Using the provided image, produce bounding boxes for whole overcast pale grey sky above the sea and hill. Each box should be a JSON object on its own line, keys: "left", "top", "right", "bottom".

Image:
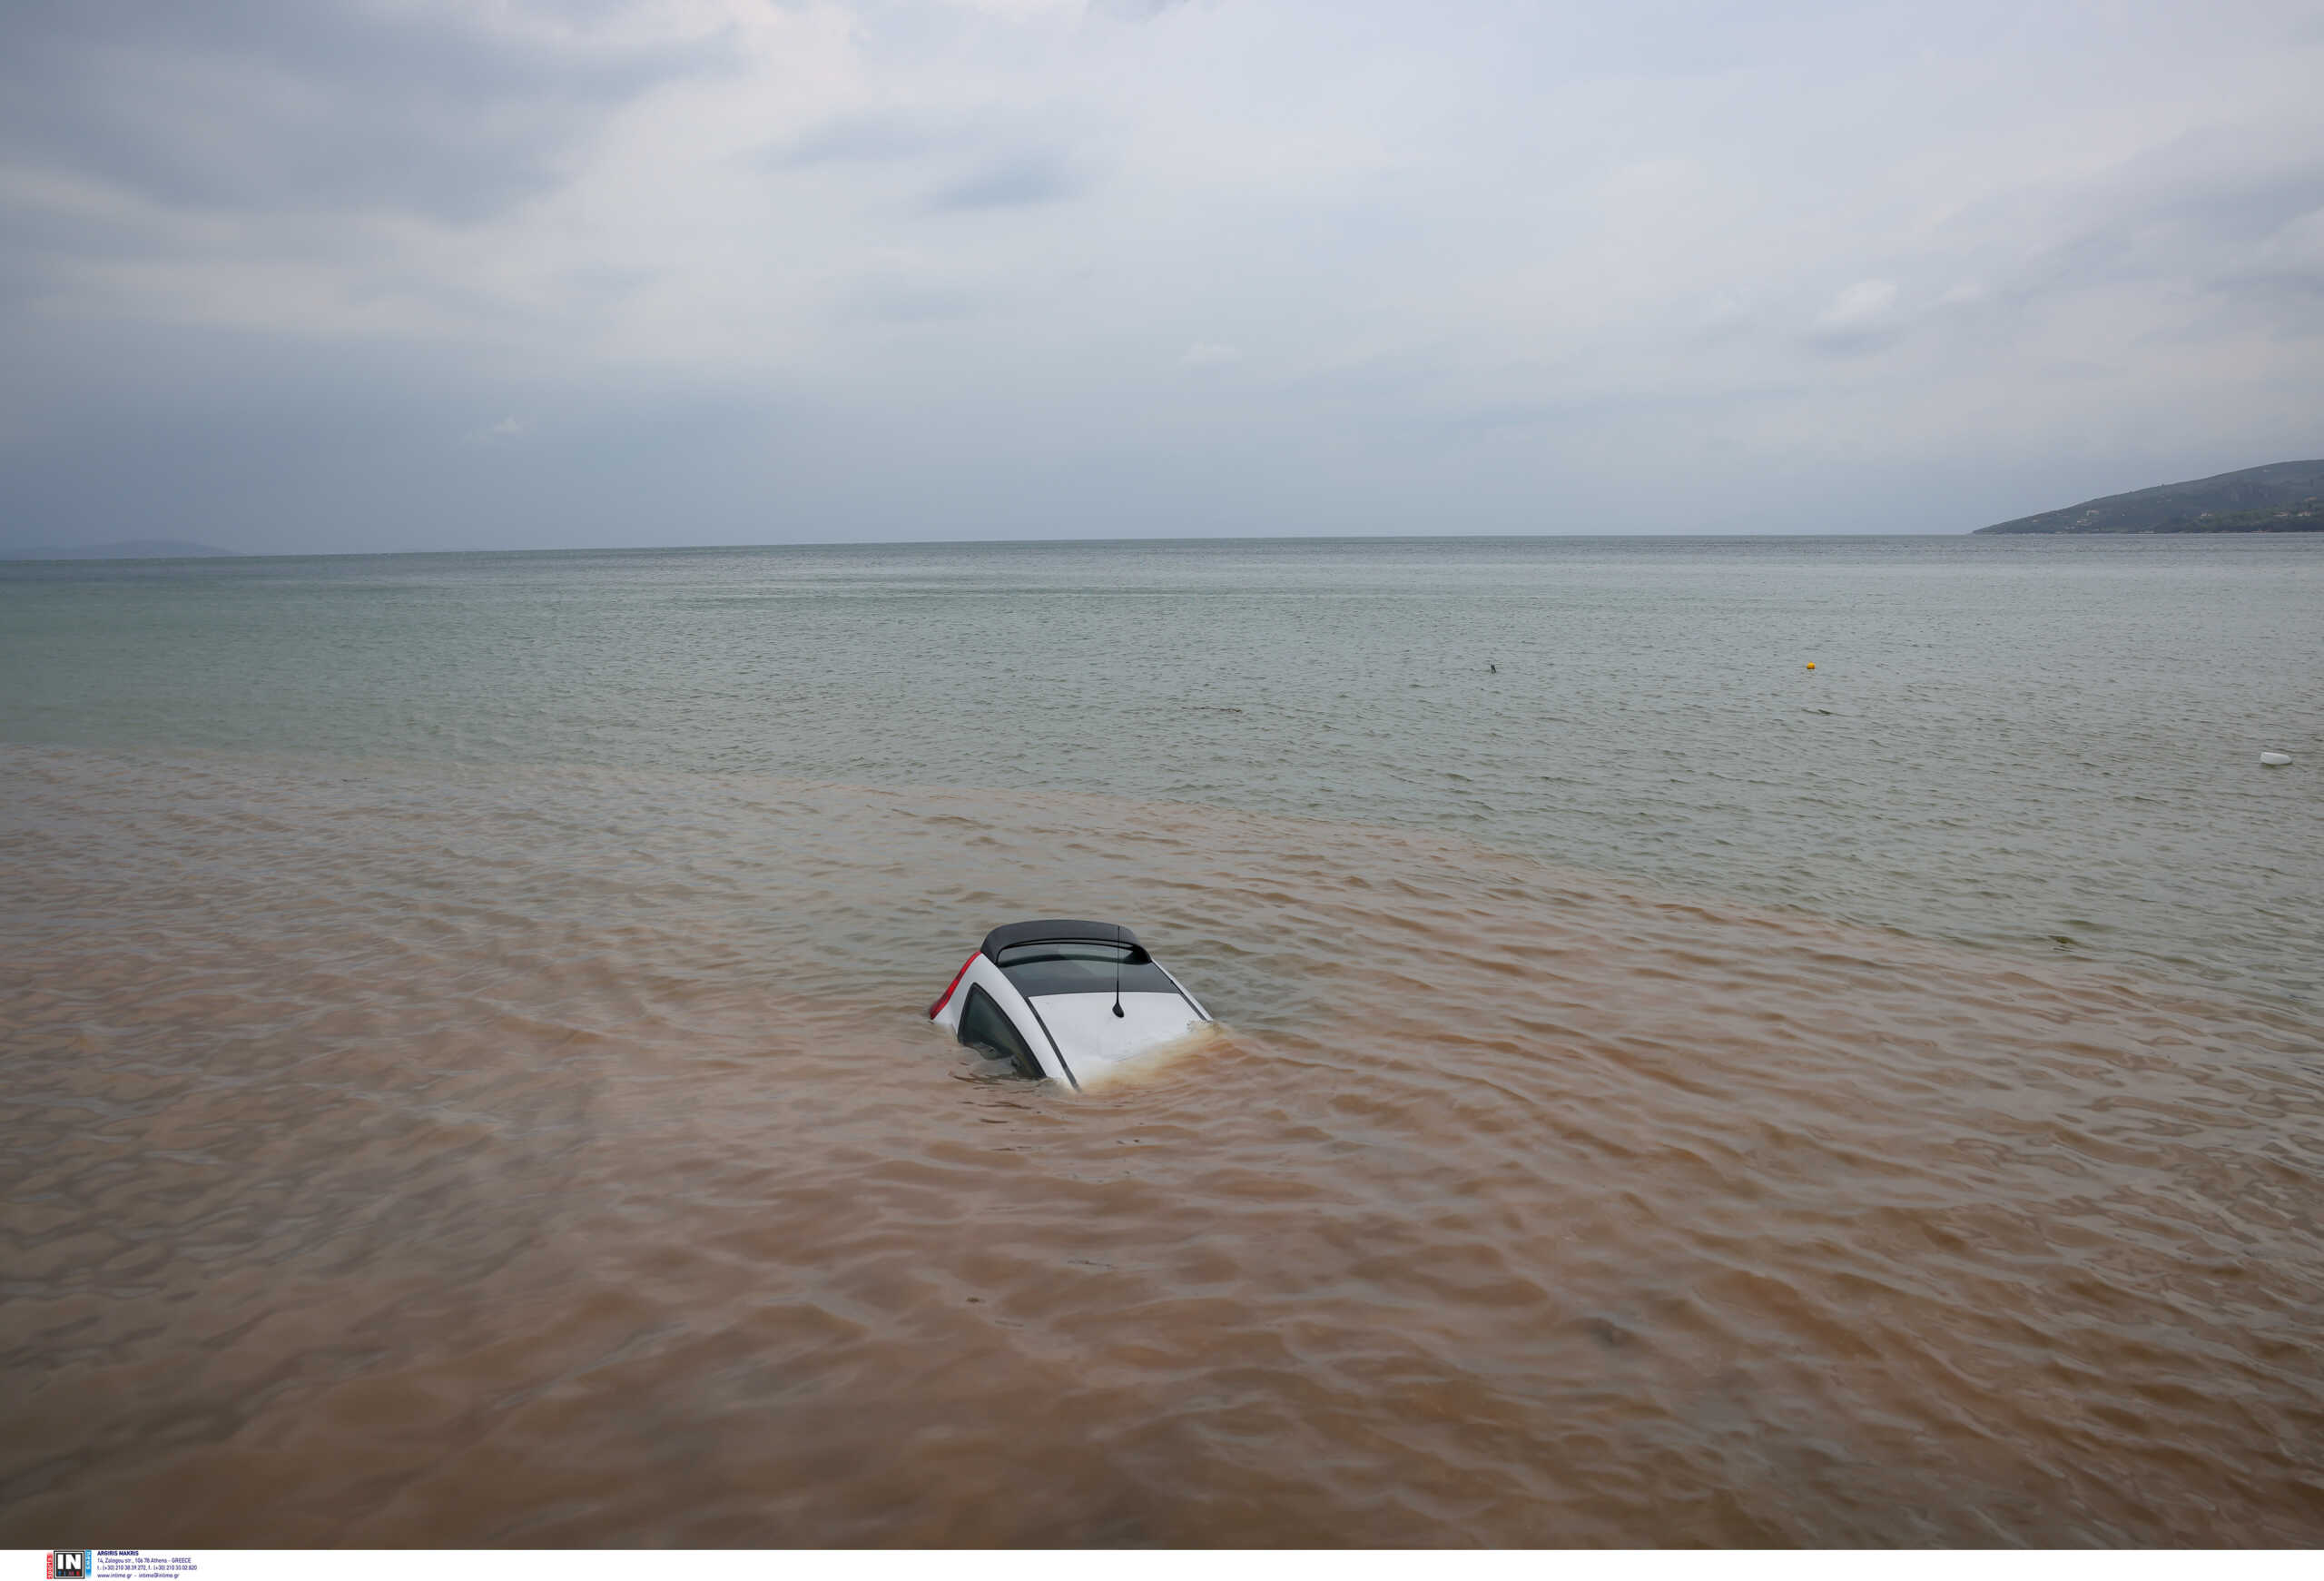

{"left": 0, "top": 0, "right": 2324, "bottom": 553}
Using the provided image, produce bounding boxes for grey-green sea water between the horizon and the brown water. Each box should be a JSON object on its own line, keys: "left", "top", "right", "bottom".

{"left": 0, "top": 537, "right": 2324, "bottom": 1007}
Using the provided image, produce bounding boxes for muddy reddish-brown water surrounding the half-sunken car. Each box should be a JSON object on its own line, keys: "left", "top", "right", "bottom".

{"left": 0, "top": 746, "right": 2324, "bottom": 1546}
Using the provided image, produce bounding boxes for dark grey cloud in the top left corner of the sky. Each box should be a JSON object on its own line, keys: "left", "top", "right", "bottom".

{"left": 0, "top": 0, "right": 723, "bottom": 221}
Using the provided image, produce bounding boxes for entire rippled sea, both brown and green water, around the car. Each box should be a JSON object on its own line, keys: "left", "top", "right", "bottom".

{"left": 0, "top": 537, "right": 2324, "bottom": 1546}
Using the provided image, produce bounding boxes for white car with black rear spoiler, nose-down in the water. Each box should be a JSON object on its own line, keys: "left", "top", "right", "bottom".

{"left": 927, "top": 918, "right": 1211, "bottom": 1091}
